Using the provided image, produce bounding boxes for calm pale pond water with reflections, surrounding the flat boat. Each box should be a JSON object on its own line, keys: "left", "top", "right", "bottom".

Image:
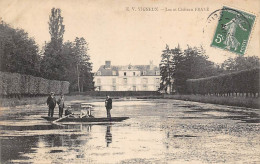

{"left": 0, "top": 100, "right": 260, "bottom": 163}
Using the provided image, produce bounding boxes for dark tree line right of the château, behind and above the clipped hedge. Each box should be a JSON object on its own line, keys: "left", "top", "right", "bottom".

{"left": 159, "top": 45, "right": 260, "bottom": 94}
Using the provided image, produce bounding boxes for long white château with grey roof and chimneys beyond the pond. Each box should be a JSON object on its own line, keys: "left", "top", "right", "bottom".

{"left": 94, "top": 61, "right": 161, "bottom": 91}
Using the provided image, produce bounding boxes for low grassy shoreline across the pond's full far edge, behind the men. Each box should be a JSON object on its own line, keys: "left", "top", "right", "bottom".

{"left": 0, "top": 95, "right": 260, "bottom": 109}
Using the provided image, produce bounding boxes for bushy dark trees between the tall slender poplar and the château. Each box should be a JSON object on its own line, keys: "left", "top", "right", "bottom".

{"left": 61, "top": 37, "right": 94, "bottom": 92}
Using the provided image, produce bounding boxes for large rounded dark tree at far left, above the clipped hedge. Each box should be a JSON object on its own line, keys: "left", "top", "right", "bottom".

{"left": 0, "top": 21, "right": 40, "bottom": 76}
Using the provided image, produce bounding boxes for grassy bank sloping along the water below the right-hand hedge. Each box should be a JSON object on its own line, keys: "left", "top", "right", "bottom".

{"left": 164, "top": 95, "right": 260, "bottom": 109}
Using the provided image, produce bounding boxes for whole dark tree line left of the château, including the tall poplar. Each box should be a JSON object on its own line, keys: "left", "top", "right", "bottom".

{"left": 0, "top": 8, "right": 94, "bottom": 92}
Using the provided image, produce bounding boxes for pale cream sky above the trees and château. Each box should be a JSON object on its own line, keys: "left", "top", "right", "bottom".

{"left": 0, "top": 0, "right": 260, "bottom": 72}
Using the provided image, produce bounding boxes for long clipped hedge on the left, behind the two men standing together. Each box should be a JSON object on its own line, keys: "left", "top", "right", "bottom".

{"left": 0, "top": 72, "right": 69, "bottom": 96}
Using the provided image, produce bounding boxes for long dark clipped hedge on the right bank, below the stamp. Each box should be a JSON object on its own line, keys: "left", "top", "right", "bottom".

{"left": 186, "top": 69, "right": 260, "bottom": 96}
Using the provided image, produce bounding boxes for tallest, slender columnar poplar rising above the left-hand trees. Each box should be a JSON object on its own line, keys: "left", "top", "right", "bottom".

{"left": 41, "top": 8, "right": 65, "bottom": 80}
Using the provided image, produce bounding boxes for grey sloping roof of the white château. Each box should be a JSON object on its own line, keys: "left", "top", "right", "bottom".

{"left": 95, "top": 65, "right": 160, "bottom": 76}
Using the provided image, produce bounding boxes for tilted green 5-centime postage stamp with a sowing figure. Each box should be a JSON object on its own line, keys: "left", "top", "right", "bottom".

{"left": 211, "top": 6, "right": 255, "bottom": 55}
